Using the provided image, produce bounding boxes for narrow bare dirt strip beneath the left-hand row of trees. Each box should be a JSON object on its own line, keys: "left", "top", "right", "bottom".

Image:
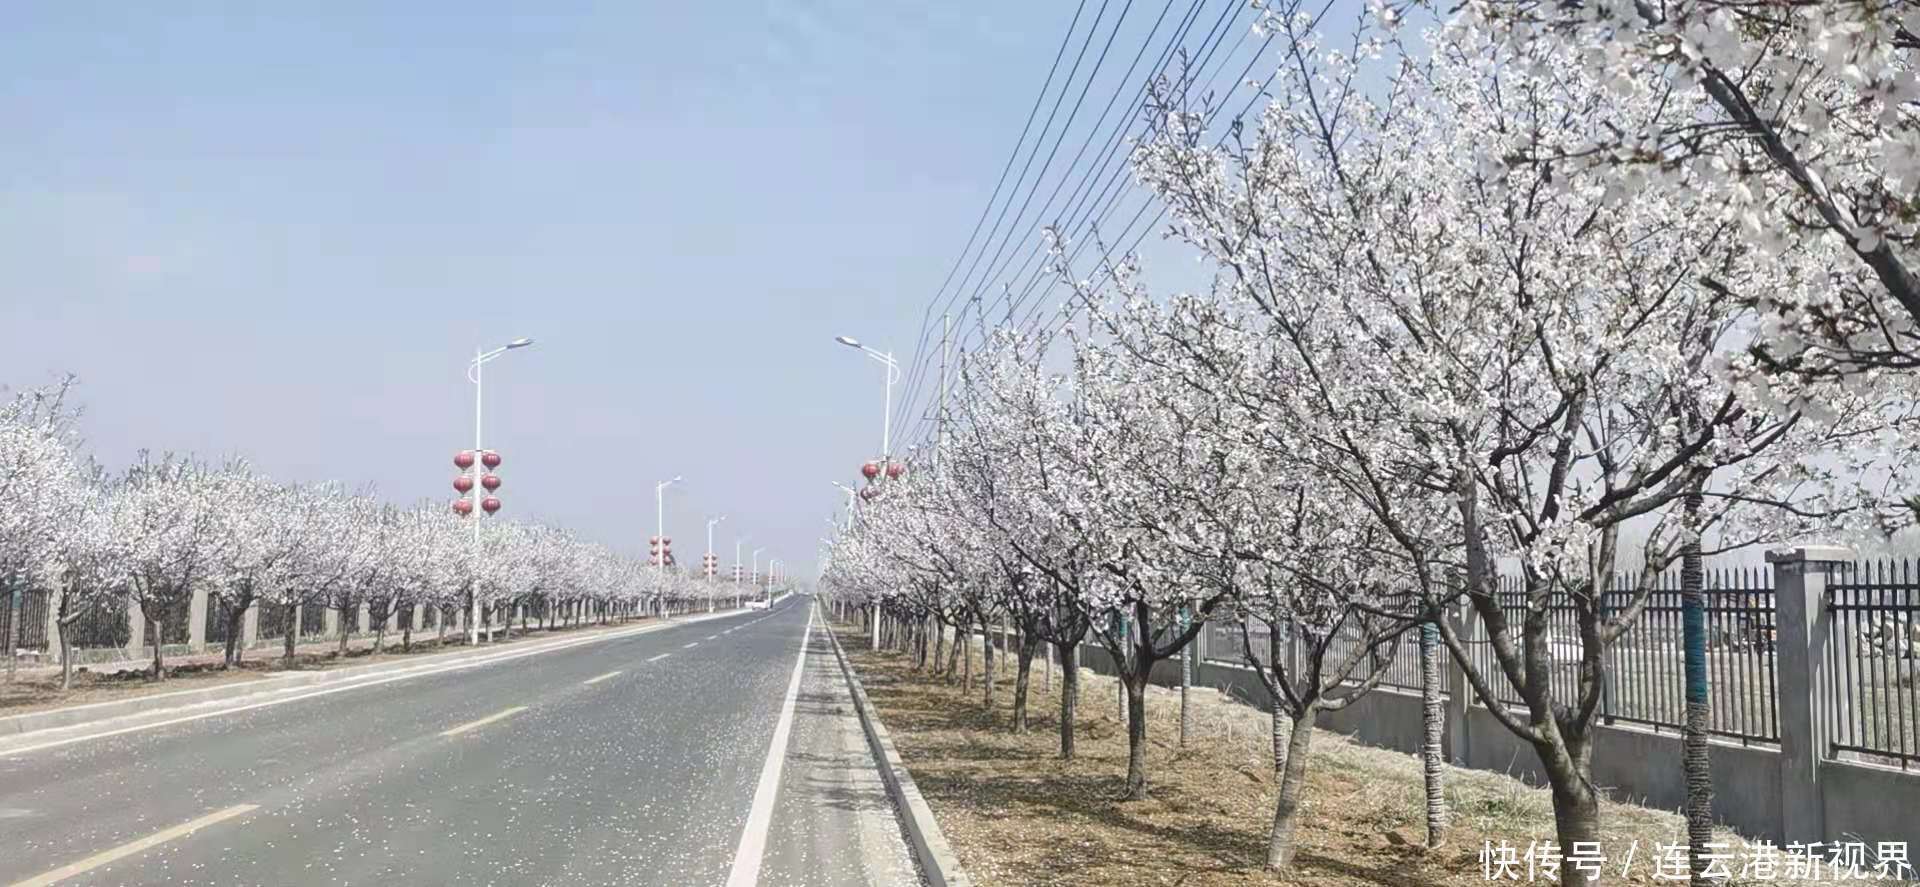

{"left": 0, "top": 618, "right": 651, "bottom": 716}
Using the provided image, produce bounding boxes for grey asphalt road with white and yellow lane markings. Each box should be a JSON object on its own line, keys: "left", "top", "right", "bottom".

{"left": 0, "top": 597, "right": 920, "bottom": 887}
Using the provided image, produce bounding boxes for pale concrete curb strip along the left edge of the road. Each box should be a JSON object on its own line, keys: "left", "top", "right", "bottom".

{"left": 0, "top": 609, "right": 755, "bottom": 739}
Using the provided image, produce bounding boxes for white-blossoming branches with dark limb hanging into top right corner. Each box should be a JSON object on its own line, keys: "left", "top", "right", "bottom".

{"left": 1455, "top": 0, "right": 1920, "bottom": 372}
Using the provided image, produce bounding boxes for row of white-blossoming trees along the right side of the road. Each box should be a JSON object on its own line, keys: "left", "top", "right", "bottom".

{"left": 824, "top": 0, "right": 1920, "bottom": 879}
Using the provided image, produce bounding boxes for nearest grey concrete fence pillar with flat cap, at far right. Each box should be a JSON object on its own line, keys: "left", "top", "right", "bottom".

{"left": 1766, "top": 545, "right": 1853, "bottom": 843}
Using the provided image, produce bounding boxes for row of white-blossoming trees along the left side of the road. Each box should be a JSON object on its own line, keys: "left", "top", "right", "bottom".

{"left": 0, "top": 380, "right": 735, "bottom": 683}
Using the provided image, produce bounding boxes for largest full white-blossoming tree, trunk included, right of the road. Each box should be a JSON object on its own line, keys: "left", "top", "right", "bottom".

{"left": 1137, "top": 12, "right": 1910, "bottom": 871}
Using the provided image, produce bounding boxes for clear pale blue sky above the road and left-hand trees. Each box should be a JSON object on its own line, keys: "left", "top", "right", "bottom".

{"left": 0, "top": 0, "right": 1290, "bottom": 568}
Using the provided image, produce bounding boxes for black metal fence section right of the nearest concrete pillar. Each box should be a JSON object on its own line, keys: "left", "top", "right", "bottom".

{"left": 1816, "top": 561, "right": 1920, "bottom": 770}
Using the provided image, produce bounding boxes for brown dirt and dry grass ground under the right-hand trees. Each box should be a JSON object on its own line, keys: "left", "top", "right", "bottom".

{"left": 839, "top": 626, "right": 1891, "bottom": 887}
